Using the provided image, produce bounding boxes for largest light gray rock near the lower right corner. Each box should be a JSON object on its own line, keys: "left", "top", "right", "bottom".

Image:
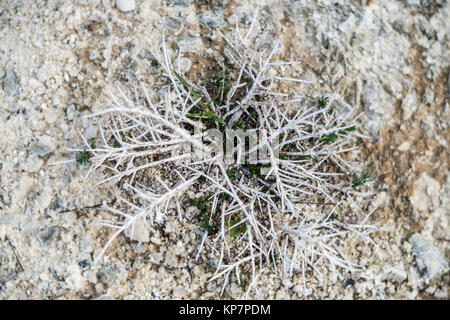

{"left": 409, "top": 233, "right": 447, "bottom": 279}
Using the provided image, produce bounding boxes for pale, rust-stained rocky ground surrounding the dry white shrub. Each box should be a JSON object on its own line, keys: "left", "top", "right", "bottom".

{"left": 0, "top": 0, "right": 450, "bottom": 299}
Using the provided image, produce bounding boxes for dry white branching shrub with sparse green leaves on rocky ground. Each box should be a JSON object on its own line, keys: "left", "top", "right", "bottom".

{"left": 73, "top": 10, "right": 376, "bottom": 297}
